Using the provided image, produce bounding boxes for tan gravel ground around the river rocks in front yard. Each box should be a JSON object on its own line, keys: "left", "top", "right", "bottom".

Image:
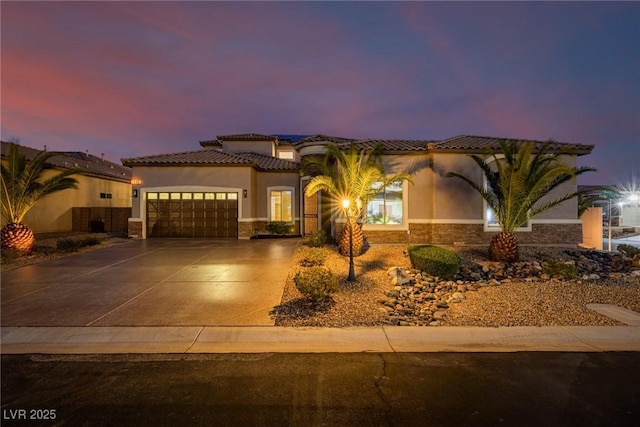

{"left": 272, "top": 245, "right": 640, "bottom": 327}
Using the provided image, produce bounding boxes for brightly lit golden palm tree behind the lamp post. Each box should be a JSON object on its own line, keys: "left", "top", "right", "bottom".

{"left": 302, "top": 144, "right": 411, "bottom": 256}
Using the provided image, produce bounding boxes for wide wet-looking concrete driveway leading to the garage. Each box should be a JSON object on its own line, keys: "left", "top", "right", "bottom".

{"left": 1, "top": 239, "right": 299, "bottom": 326}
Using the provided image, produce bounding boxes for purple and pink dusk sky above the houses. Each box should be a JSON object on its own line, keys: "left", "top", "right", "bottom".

{"left": 0, "top": 1, "right": 640, "bottom": 184}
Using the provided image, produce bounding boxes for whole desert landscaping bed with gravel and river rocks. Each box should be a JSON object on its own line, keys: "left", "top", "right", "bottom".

{"left": 272, "top": 244, "right": 640, "bottom": 327}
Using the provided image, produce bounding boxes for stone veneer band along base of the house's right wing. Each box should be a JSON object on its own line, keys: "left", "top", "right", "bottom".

{"left": 336, "top": 223, "right": 582, "bottom": 245}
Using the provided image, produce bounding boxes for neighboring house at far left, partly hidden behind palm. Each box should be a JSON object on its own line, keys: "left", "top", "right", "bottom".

{"left": 2, "top": 141, "right": 131, "bottom": 233}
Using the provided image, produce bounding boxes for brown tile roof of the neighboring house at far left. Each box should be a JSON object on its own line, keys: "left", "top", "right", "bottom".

{"left": 2, "top": 141, "right": 131, "bottom": 182}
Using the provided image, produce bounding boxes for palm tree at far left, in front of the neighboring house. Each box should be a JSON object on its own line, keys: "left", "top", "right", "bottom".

{"left": 0, "top": 143, "right": 82, "bottom": 255}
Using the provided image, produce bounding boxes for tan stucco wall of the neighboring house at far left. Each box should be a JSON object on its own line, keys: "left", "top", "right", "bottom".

{"left": 23, "top": 171, "right": 131, "bottom": 233}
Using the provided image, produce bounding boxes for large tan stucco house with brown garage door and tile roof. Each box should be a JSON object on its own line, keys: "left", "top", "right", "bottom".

{"left": 122, "top": 134, "right": 593, "bottom": 245}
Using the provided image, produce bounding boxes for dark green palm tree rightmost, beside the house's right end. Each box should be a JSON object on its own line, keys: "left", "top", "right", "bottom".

{"left": 446, "top": 141, "right": 595, "bottom": 262}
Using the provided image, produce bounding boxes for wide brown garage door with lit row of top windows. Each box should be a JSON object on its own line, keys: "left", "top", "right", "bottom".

{"left": 147, "top": 192, "right": 238, "bottom": 238}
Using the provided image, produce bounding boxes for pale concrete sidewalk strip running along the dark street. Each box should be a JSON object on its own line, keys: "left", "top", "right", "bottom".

{"left": 1, "top": 326, "right": 640, "bottom": 354}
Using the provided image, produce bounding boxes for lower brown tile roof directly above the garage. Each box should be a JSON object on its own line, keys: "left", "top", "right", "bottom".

{"left": 122, "top": 149, "right": 300, "bottom": 171}
